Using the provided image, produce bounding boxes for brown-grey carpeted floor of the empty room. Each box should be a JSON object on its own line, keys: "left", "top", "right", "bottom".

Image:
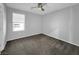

{"left": 2, "top": 34, "right": 79, "bottom": 55}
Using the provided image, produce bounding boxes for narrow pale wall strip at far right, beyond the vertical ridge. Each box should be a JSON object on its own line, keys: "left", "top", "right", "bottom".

{"left": 72, "top": 5, "right": 79, "bottom": 46}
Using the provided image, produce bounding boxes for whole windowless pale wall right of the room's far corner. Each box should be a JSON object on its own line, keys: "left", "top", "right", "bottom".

{"left": 43, "top": 5, "right": 79, "bottom": 46}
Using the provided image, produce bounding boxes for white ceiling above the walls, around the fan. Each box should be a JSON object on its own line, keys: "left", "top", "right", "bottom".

{"left": 6, "top": 3, "right": 77, "bottom": 15}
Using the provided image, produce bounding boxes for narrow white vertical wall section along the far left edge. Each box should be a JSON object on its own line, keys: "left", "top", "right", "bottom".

{"left": 0, "top": 3, "right": 6, "bottom": 52}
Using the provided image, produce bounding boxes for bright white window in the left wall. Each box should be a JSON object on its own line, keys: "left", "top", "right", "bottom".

{"left": 12, "top": 13, "right": 25, "bottom": 31}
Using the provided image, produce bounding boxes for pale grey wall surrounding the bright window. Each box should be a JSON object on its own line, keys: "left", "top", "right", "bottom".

{"left": 6, "top": 7, "right": 41, "bottom": 41}
